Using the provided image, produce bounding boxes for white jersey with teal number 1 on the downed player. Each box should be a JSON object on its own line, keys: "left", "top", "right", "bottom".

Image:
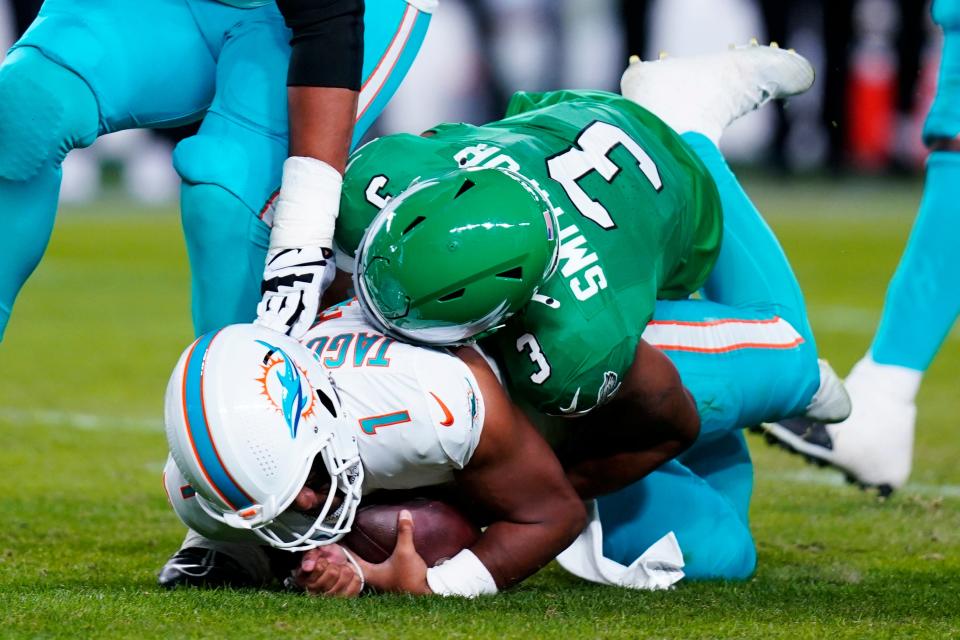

{"left": 302, "top": 300, "right": 484, "bottom": 493}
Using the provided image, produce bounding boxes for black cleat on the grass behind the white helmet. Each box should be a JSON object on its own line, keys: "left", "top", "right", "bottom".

{"left": 157, "top": 547, "right": 262, "bottom": 589}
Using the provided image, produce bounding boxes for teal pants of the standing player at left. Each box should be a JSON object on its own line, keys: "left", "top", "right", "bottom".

{"left": 0, "top": 0, "right": 429, "bottom": 335}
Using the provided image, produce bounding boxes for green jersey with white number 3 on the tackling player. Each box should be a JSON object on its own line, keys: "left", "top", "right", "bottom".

{"left": 336, "top": 91, "right": 722, "bottom": 414}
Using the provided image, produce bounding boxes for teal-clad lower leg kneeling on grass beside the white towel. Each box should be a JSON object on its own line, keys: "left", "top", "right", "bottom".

{"left": 597, "top": 450, "right": 757, "bottom": 580}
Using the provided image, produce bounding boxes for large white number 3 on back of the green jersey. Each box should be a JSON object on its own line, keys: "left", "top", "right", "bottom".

{"left": 547, "top": 121, "right": 663, "bottom": 229}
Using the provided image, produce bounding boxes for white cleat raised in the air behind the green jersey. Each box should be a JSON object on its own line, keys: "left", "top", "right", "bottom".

{"left": 620, "top": 39, "right": 814, "bottom": 142}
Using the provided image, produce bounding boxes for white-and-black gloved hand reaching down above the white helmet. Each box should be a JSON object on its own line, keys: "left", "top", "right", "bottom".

{"left": 255, "top": 247, "right": 337, "bottom": 339}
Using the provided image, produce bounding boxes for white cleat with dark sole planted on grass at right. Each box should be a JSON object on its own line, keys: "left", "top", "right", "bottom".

{"left": 764, "top": 357, "right": 920, "bottom": 496}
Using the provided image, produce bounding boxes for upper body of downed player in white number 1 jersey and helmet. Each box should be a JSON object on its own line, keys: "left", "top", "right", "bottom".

{"left": 161, "top": 302, "right": 585, "bottom": 596}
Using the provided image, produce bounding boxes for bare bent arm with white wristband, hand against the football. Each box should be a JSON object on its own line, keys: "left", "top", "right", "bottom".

{"left": 366, "top": 349, "right": 586, "bottom": 597}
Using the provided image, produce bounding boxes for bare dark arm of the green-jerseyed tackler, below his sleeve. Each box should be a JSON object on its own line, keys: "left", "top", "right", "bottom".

{"left": 562, "top": 340, "right": 700, "bottom": 499}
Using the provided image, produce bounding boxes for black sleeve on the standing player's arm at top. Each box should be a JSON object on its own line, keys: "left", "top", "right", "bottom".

{"left": 277, "top": 0, "right": 364, "bottom": 91}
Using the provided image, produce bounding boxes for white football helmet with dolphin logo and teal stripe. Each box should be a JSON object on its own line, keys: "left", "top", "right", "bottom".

{"left": 164, "top": 324, "right": 363, "bottom": 551}
